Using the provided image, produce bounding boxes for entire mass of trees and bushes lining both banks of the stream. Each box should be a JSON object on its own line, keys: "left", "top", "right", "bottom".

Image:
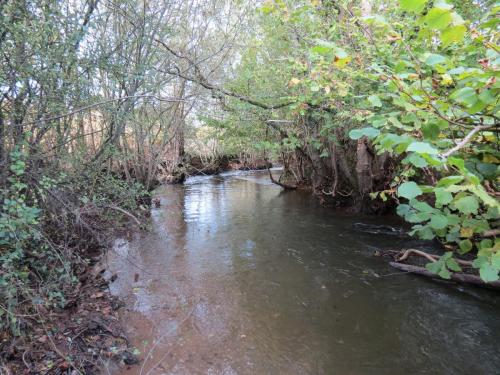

{"left": 0, "top": 0, "right": 500, "bottom": 356}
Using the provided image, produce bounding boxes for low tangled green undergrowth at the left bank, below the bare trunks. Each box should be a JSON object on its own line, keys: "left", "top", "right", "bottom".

{"left": 0, "top": 147, "right": 148, "bottom": 343}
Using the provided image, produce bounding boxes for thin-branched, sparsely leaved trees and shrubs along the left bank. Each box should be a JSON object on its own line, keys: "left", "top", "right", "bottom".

{"left": 0, "top": 0, "right": 250, "bottom": 345}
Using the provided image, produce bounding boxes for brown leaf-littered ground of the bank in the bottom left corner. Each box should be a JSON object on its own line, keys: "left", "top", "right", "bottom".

{"left": 0, "top": 244, "right": 138, "bottom": 375}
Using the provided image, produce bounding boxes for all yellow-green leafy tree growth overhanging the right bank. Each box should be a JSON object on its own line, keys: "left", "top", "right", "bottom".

{"left": 221, "top": 0, "right": 500, "bottom": 281}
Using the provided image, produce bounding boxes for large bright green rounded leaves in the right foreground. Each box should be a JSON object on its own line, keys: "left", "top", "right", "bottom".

{"left": 358, "top": 1, "right": 500, "bottom": 281}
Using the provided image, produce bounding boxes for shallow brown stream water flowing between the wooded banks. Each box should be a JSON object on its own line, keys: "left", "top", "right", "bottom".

{"left": 108, "top": 172, "right": 500, "bottom": 375}
